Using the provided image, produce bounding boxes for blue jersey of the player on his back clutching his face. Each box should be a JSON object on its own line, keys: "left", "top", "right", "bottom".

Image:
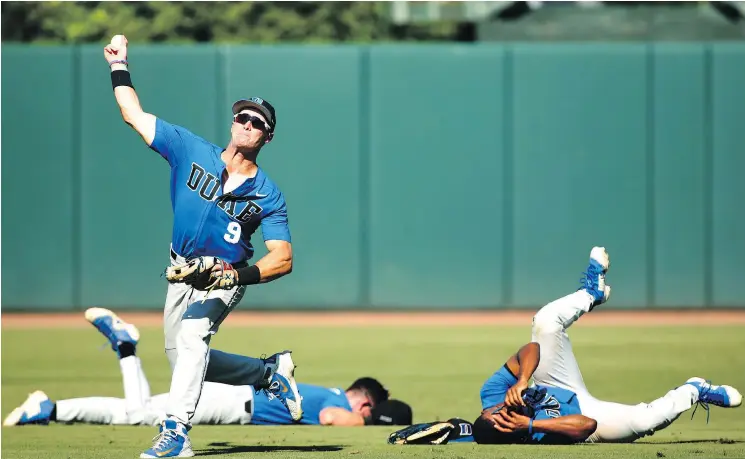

{"left": 481, "top": 365, "right": 582, "bottom": 443}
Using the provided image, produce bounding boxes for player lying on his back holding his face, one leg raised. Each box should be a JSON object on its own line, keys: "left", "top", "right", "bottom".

{"left": 389, "top": 247, "right": 742, "bottom": 444}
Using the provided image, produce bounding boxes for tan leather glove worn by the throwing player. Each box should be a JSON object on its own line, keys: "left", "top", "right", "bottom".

{"left": 165, "top": 256, "right": 237, "bottom": 290}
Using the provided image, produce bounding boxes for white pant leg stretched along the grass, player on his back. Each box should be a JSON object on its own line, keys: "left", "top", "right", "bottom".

{"left": 577, "top": 384, "right": 698, "bottom": 443}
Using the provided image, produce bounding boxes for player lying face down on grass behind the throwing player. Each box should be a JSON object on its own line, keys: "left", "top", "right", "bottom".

{"left": 4, "top": 308, "right": 412, "bottom": 432}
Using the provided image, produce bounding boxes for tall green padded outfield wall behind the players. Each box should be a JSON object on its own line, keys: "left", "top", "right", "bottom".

{"left": 2, "top": 43, "right": 745, "bottom": 310}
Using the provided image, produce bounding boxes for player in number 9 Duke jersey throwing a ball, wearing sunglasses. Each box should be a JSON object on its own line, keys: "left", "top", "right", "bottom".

{"left": 104, "top": 35, "right": 302, "bottom": 458}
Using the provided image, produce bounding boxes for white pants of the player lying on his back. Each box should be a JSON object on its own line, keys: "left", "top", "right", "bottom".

{"left": 532, "top": 290, "right": 698, "bottom": 443}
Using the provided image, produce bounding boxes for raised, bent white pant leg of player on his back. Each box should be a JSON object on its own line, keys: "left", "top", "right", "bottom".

{"left": 532, "top": 290, "right": 594, "bottom": 393}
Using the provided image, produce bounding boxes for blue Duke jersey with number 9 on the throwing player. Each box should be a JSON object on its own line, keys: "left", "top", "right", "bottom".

{"left": 150, "top": 118, "right": 291, "bottom": 263}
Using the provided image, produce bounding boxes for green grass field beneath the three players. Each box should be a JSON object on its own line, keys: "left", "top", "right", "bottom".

{"left": 2, "top": 317, "right": 745, "bottom": 459}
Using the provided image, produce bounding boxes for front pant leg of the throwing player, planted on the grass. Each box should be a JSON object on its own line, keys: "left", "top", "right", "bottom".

{"left": 164, "top": 250, "right": 245, "bottom": 425}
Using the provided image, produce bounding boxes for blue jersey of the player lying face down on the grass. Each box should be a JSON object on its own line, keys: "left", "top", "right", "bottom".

{"left": 251, "top": 383, "right": 352, "bottom": 425}
